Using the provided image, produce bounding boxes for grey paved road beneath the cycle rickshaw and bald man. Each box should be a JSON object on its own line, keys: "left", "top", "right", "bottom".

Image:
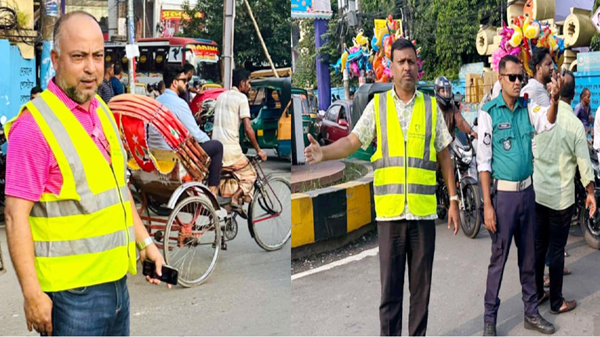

{"left": 0, "top": 151, "right": 291, "bottom": 335}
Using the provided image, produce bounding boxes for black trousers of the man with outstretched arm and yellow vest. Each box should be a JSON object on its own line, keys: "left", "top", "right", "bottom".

{"left": 377, "top": 220, "right": 435, "bottom": 336}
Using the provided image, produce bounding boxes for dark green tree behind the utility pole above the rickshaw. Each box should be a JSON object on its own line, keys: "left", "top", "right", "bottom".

{"left": 182, "top": 0, "right": 291, "bottom": 69}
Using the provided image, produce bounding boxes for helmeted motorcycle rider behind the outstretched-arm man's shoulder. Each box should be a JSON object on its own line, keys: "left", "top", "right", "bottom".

{"left": 433, "top": 76, "right": 477, "bottom": 139}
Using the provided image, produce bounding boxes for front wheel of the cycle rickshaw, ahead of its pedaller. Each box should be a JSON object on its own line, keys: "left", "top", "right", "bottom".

{"left": 248, "top": 177, "right": 292, "bottom": 251}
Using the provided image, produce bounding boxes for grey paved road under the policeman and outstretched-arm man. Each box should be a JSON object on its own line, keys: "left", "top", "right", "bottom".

{"left": 292, "top": 223, "right": 600, "bottom": 335}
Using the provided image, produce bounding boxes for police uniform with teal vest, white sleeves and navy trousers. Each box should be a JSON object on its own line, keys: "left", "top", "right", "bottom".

{"left": 477, "top": 95, "right": 554, "bottom": 325}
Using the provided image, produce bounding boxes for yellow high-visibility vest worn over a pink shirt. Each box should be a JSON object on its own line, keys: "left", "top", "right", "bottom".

{"left": 5, "top": 90, "right": 136, "bottom": 292}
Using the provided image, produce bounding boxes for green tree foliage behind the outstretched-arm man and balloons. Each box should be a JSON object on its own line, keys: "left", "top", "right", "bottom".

{"left": 296, "top": 0, "right": 502, "bottom": 86}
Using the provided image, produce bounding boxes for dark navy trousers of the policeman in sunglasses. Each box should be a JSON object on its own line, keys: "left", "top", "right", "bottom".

{"left": 484, "top": 186, "right": 539, "bottom": 324}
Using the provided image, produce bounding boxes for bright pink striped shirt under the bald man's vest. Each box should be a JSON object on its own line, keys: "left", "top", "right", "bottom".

{"left": 5, "top": 78, "right": 110, "bottom": 202}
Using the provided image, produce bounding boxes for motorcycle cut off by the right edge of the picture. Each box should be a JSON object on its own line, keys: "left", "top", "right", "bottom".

{"left": 573, "top": 141, "right": 600, "bottom": 249}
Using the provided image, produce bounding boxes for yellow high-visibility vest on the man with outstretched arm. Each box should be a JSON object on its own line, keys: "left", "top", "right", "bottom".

{"left": 371, "top": 89, "right": 437, "bottom": 218}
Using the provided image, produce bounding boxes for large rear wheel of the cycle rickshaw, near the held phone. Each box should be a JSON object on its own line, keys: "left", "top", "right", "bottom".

{"left": 163, "top": 196, "right": 221, "bottom": 287}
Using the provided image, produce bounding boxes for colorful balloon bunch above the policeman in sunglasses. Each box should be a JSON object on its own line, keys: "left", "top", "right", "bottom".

{"left": 492, "top": 16, "right": 565, "bottom": 76}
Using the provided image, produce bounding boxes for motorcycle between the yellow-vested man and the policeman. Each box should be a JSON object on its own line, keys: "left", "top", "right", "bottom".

{"left": 436, "top": 128, "right": 483, "bottom": 238}
